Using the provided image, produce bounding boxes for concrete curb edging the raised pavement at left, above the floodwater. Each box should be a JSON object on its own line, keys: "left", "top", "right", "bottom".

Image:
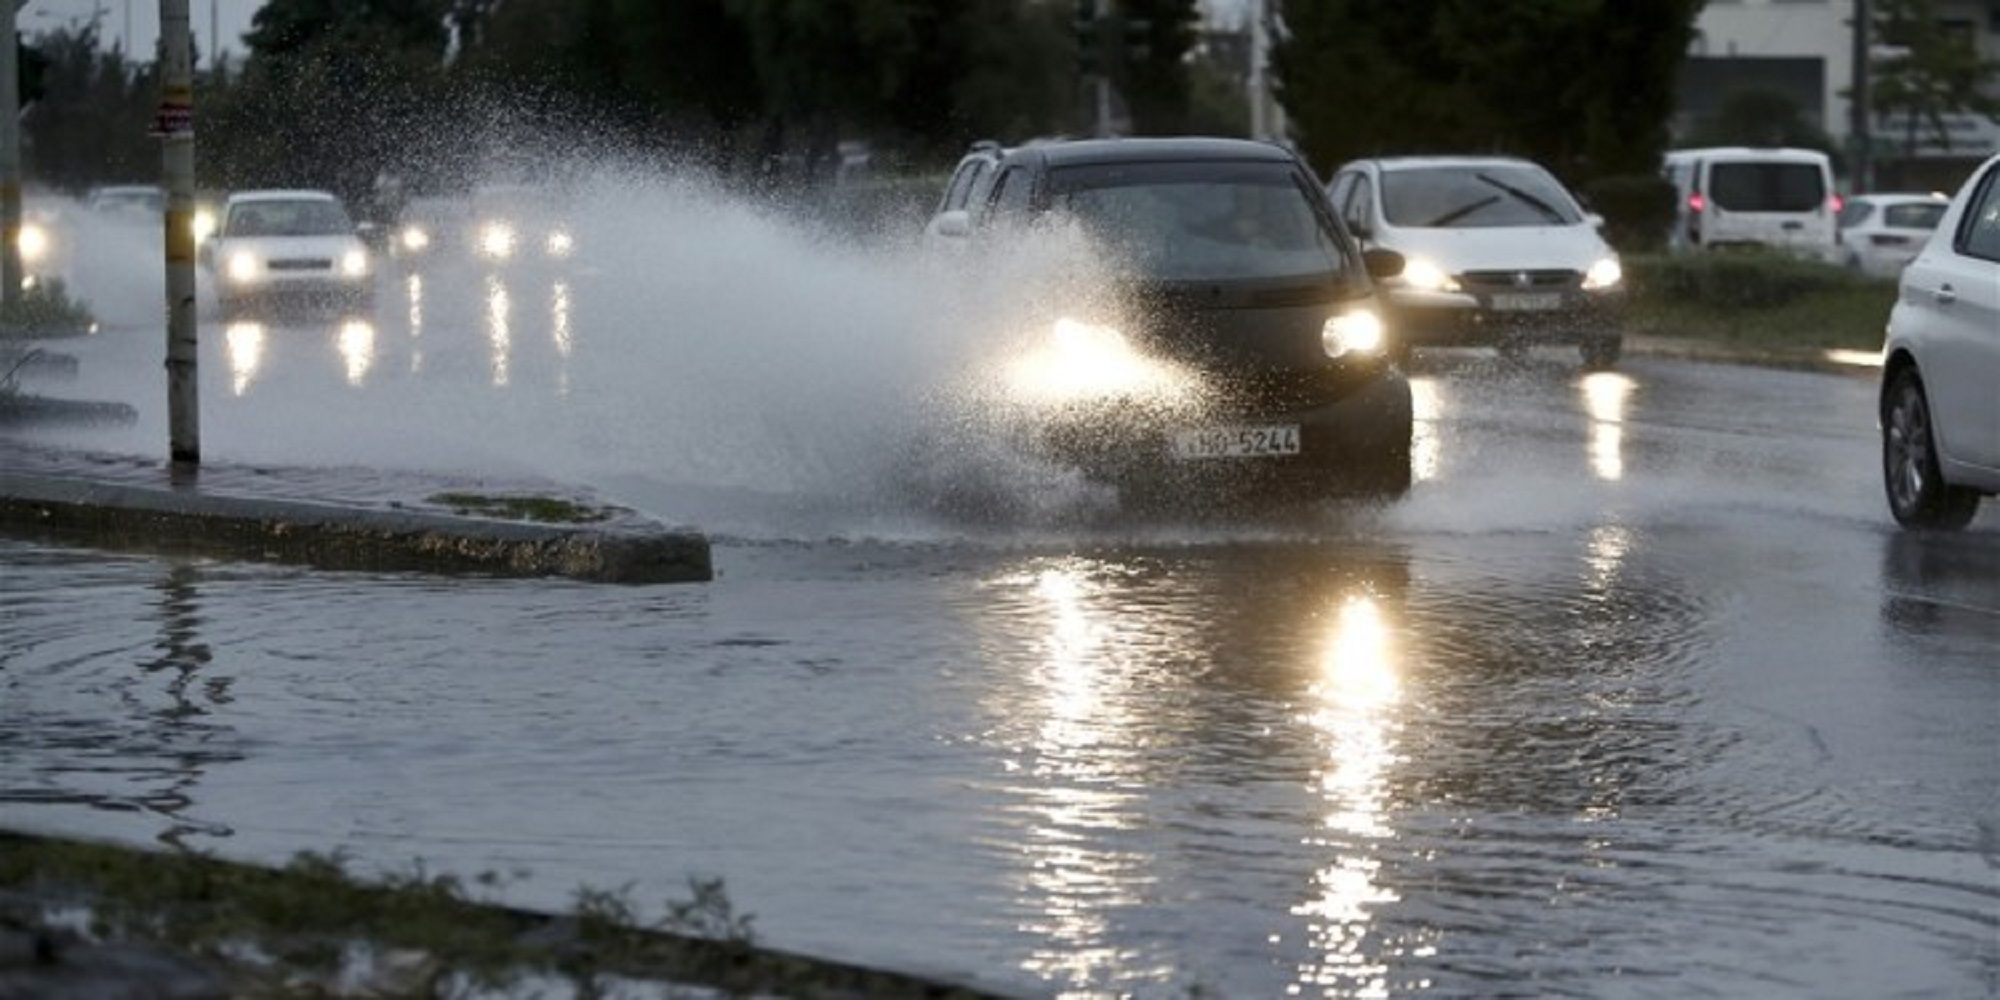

{"left": 0, "top": 470, "right": 714, "bottom": 584}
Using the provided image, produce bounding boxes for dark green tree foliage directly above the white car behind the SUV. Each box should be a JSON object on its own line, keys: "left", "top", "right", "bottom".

{"left": 1274, "top": 0, "right": 1702, "bottom": 184}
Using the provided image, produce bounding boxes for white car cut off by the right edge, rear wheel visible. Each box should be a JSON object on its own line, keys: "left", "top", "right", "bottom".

{"left": 1880, "top": 156, "right": 2000, "bottom": 528}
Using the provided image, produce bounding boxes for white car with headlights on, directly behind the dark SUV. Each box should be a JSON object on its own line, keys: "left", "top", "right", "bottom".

{"left": 1326, "top": 156, "right": 1624, "bottom": 368}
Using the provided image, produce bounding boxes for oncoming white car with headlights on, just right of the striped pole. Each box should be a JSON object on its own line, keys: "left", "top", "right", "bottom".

{"left": 202, "top": 190, "right": 374, "bottom": 316}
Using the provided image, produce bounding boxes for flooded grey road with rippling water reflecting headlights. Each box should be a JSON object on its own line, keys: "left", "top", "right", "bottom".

{"left": 0, "top": 207, "right": 2000, "bottom": 998}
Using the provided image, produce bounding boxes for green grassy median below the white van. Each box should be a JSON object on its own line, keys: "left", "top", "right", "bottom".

{"left": 1626, "top": 252, "right": 1896, "bottom": 350}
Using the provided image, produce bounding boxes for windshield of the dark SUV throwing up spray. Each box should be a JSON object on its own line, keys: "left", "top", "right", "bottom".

{"left": 1048, "top": 162, "right": 1350, "bottom": 284}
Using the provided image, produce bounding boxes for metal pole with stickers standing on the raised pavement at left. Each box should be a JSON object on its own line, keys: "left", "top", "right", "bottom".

{"left": 154, "top": 0, "right": 202, "bottom": 468}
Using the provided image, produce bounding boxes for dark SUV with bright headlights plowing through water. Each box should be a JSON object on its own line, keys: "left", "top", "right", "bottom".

{"left": 928, "top": 138, "right": 1412, "bottom": 496}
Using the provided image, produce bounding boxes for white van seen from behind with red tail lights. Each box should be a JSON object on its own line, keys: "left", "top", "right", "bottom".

{"left": 1662, "top": 146, "right": 1840, "bottom": 260}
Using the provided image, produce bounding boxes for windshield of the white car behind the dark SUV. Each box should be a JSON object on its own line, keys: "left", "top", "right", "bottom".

{"left": 1382, "top": 164, "right": 1584, "bottom": 228}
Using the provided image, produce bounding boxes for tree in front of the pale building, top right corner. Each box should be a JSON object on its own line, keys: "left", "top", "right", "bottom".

{"left": 1868, "top": 0, "right": 2000, "bottom": 154}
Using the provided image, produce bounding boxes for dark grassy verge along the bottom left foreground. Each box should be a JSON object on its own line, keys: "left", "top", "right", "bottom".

{"left": 0, "top": 832, "right": 986, "bottom": 1000}
